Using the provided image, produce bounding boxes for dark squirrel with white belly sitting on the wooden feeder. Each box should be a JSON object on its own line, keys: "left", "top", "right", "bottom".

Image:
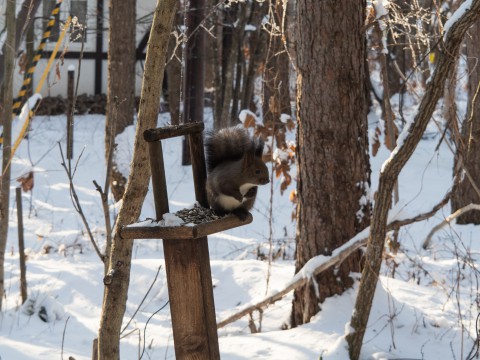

{"left": 205, "top": 126, "right": 270, "bottom": 221}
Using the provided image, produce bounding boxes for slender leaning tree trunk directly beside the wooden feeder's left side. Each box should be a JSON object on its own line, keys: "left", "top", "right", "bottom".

{"left": 98, "top": 0, "right": 178, "bottom": 360}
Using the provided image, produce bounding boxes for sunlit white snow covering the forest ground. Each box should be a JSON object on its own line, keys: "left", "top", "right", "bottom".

{"left": 0, "top": 87, "right": 480, "bottom": 360}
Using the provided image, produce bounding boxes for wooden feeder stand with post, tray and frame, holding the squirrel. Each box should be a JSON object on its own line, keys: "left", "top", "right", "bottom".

{"left": 120, "top": 123, "right": 252, "bottom": 360}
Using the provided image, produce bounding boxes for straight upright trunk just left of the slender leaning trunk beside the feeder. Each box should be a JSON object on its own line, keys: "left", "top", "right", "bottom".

{"left": 105, "top": 0, "right": 137, "bottom": 201}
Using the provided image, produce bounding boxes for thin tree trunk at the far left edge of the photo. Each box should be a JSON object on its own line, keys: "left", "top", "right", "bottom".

{"left": 0, "top": 0, "right": 15, "bottom": 310}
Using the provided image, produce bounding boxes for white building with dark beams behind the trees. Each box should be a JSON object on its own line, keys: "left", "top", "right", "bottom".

{"left": 6, "top": 0, "right": 156, "bottom": 98}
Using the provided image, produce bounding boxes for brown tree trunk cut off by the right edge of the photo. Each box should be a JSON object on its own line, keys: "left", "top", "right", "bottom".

{"left": 452, "top": 23, "right": 480, "bottom": 224}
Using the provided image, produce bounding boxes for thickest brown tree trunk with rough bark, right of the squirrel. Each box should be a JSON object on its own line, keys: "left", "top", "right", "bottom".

{"left": 291, "top": 0, "right": 370, "bottom": 326}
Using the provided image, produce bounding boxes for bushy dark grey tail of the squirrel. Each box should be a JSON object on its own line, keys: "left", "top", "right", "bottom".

{"left": 205, "top": 126, "right": 264, "bottom": 173}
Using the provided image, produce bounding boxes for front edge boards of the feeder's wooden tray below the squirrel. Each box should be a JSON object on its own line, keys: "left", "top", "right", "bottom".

{"left": 120, "top": 214, "right": 253, "bottom": 240}
